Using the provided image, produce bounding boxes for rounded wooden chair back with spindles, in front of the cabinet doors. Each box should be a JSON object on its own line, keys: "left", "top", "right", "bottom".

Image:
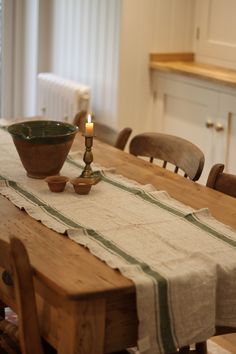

{"left": 129, "top": 133, "right": 205, "bottom": 181}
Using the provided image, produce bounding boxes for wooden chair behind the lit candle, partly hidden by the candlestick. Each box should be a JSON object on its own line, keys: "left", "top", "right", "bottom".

{"left": 73, "top": 111, "right": 132, "bottom": 150}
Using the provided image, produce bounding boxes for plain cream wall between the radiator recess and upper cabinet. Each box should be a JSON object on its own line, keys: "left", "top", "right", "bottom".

{"left": 117, "top": 0, "right": 195, "bottom": 133}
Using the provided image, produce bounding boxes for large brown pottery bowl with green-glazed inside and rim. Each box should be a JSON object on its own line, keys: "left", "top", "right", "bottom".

{"left": 8, "top": 120, "right": 78, "bottom": 178}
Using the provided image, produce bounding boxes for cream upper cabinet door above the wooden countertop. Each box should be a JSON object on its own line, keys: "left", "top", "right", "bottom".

{"left": 196, "top": 0, "right": 236, "bottom": 68}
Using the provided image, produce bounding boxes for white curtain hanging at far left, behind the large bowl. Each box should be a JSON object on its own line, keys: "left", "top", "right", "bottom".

{"left": 1, "top": 0, "right": 51, "bottom": 119}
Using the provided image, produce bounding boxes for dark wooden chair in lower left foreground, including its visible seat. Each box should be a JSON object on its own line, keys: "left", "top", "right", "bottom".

{"left": 0, "top": 237, "right": 56, "bottom": 354}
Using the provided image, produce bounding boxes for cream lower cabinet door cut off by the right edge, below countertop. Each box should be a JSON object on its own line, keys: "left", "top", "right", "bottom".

{"left": 220, "top": 94, "right": 236, "bottom": 174}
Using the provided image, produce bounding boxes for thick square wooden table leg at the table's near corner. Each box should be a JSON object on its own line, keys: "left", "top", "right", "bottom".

{"left": 58, "top": 299, "right": 106, "bottom": 354}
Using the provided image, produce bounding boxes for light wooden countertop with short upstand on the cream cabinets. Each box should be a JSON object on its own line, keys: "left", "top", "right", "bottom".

{"left": 149, "top": 53, "right": 236, "bottom": 88}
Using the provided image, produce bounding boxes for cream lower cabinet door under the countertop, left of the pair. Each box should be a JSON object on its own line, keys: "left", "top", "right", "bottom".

{"left": 156, "top": 77, "right": 225, "bottom": 184}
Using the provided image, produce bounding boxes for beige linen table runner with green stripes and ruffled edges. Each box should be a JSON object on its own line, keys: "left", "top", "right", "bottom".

{"left": 0, "top": 129, "right": 236, "bottom": 354}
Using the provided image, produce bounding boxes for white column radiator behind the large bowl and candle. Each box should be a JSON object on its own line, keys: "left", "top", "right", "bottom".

{"left": 37, "top": 73, "right": 90, "bottom": 123}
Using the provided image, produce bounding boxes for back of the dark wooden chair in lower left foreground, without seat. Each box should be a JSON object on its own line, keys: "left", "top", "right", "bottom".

{"left": 0, "top": 237, "right": 43, "bottom": 354}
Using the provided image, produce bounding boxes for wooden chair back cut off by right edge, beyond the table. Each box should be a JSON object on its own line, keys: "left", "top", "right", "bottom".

{"left": 206, "top": 163, "right": 236, "bottom": 198}
